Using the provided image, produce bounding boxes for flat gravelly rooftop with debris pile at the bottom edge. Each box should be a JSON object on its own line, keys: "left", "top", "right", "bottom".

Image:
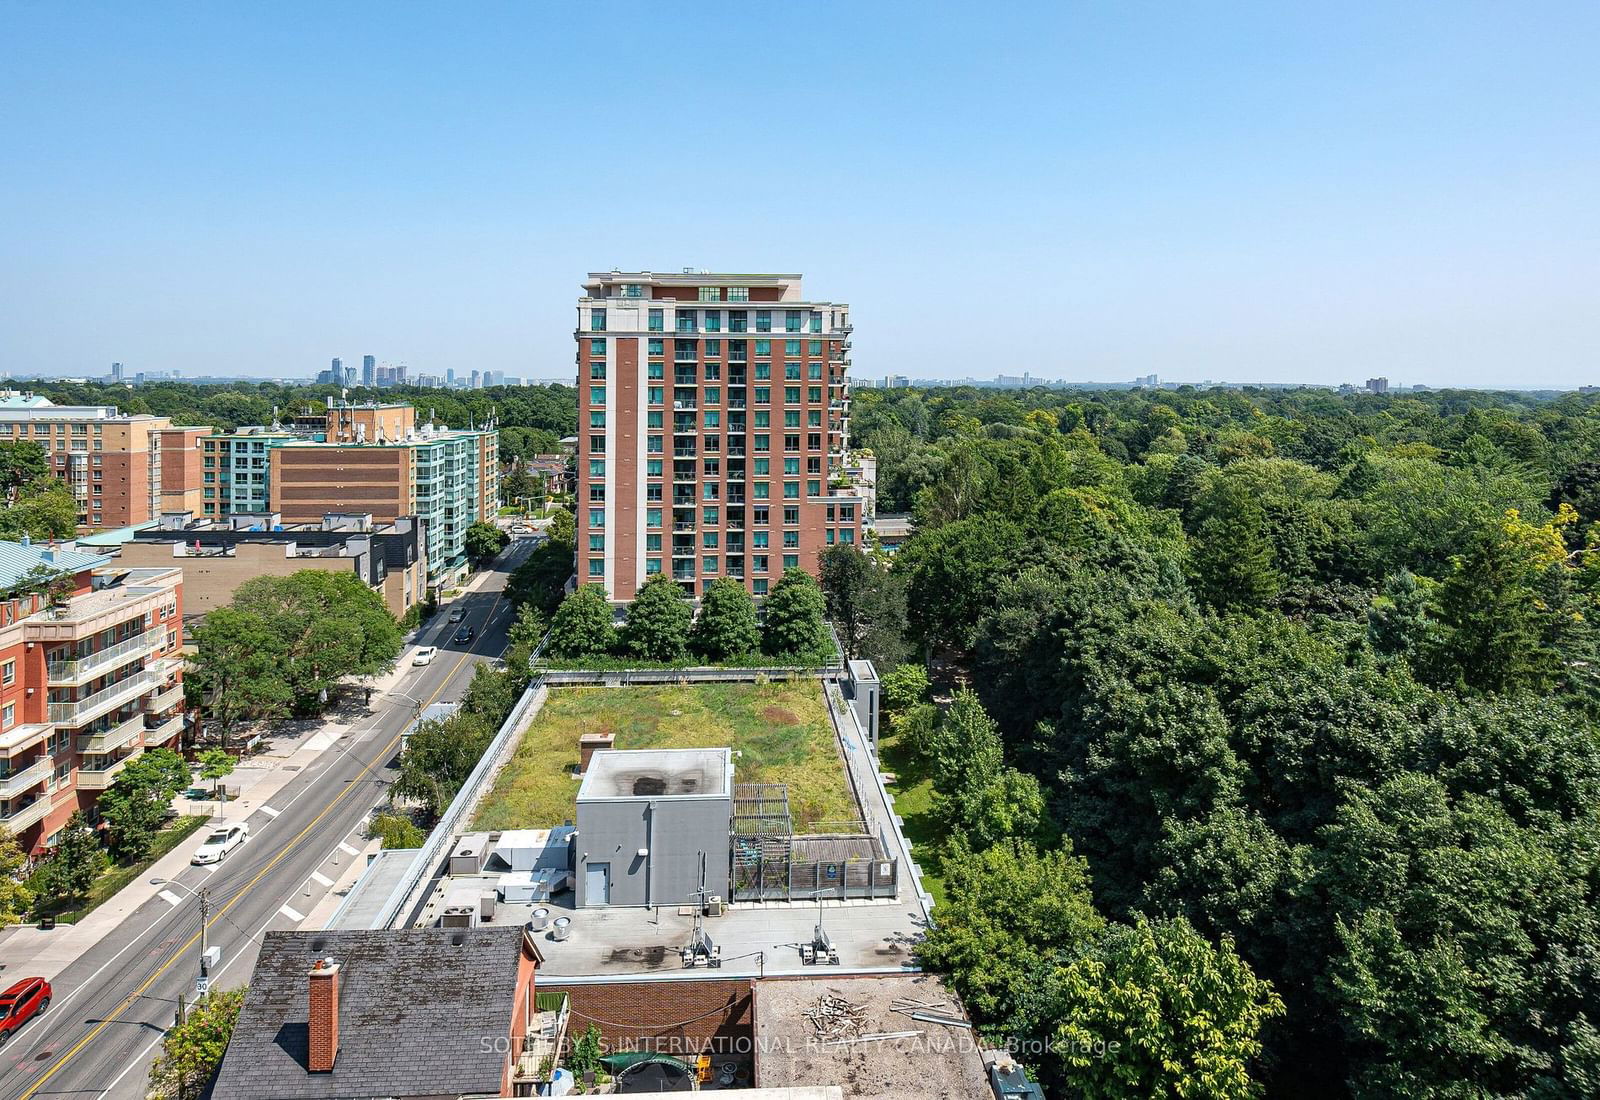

{"left": 755, "top": 974, "right": 994, "bottom": 1100}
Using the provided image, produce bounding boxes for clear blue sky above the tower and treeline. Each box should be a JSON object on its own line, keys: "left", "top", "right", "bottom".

{"left": 0, "top": 0, "right": 1600, "bottom": 385}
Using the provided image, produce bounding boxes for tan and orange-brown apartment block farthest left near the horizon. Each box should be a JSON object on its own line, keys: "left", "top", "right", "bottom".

{"left": 0, "top": 390, "right": 211, "bottom": 528}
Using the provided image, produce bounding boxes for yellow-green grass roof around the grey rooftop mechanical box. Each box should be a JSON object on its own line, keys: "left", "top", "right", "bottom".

{"left": 472, "top": 680, "right": 856, "bottom": 830}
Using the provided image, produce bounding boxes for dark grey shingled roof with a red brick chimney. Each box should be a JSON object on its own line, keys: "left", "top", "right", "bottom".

{"left": 213, "top": 927, "right": 538, "bottom": 1100}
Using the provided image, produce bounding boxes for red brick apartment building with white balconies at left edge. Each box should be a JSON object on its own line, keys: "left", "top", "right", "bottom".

{"left": 0, "top": 542, "right": 184, "bottom": 852}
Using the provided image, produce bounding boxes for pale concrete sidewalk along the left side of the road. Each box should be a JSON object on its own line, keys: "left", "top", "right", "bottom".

{"left": 0, "top": 569, "right": 512, "bottom": 978}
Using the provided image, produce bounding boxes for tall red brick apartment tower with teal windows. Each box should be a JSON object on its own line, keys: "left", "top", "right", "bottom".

{"left": 576, "top": 270, "right": 862, "bottom": 601}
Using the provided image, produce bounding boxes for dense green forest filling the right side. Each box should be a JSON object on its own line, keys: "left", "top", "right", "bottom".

{"left": 824, "top": 382, "right": 1600, "bottom": 1097}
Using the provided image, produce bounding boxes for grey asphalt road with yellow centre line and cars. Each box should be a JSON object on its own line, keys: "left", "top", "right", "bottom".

{"left": 0, "top": 539, "right": 533, "bottom": 1100}
